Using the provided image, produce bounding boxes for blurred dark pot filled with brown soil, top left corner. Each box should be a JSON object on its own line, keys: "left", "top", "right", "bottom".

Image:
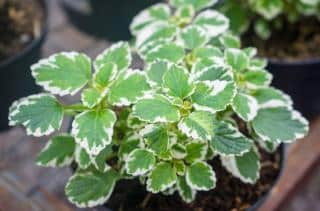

{"left": 0, "top": 0, "right": 47, "bottom": 130}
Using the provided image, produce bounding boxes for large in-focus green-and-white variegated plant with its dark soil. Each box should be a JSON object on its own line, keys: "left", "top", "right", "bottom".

{"left": 9, "top": 0, "right": 308, "bottom": 210}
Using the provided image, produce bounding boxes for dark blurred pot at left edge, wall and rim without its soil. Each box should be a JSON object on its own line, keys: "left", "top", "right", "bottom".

{"left": 0, "top": 0, "right": 48, "bottom": 130}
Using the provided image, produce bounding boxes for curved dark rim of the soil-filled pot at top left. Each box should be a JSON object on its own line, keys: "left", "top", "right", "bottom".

{"left": 0, "top": 0, "right": 49, "bottom": 68}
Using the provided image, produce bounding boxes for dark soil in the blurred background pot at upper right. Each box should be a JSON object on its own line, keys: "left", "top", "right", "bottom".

{"left": 243, "top": 17, "right": 320, "bottom": 61}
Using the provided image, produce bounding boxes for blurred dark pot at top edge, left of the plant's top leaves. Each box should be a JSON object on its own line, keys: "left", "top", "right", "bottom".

{"left": 61, "top": 0, "right": 160, "bottom": 41}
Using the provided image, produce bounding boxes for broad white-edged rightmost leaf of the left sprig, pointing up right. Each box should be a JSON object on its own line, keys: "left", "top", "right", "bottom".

{"left": 108, "top": 69, "right": 150, "bottom": 106}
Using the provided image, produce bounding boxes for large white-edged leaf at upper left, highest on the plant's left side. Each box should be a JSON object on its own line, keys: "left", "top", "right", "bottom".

{"left": 31, "top": 52, "right": 91, "bottom": 96}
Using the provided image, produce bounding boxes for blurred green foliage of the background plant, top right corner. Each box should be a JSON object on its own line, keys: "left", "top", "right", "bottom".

{"left": 219, "top": 0, "right": 320, "bottom": 39}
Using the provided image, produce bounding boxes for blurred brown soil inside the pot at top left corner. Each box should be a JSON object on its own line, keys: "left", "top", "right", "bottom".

{"left": 0, "top": 0, "right": 44, "bottom": 61}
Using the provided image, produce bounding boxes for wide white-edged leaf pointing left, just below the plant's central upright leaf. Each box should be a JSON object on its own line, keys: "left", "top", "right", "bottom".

{"left": 132, "top": 94, "right": 180, "bottom": 123}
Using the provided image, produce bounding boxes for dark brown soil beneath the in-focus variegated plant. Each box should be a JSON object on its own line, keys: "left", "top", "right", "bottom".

{"left": 106, "top": 148, "right": 280, "bottom": 211}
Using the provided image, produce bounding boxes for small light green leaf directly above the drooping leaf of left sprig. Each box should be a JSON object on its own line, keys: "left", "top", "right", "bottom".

{"left": 81, "top": 88, "right": 104, "bottom": 108}
